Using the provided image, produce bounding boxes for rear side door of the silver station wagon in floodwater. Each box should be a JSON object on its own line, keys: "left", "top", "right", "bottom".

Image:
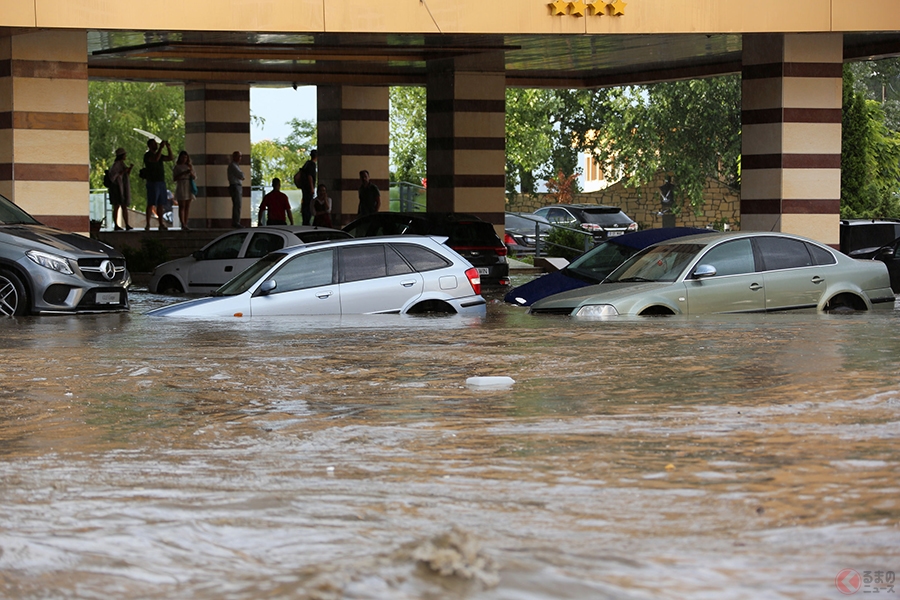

{"left": 340, "top": 244, "right": 425, "bottom": 314}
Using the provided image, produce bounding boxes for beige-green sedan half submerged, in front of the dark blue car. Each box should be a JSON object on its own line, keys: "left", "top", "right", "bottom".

{"left": 530, "top": 232, "right": 894, "bottom": 317}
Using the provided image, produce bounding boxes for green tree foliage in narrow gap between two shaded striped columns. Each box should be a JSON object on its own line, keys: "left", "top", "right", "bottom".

{"left": 389, "top": 86, "right": 427, "bottom": 184}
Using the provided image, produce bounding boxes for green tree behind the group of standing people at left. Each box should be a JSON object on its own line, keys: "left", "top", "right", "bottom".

{"left": 88, "top": 81, "right": 184, "bottom": 210}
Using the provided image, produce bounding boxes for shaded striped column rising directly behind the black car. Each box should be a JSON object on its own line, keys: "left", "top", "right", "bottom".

{"left": 427, "top": 53, "right": 506, "bottom": 235}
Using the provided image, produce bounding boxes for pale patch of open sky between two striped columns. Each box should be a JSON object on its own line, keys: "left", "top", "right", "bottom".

{"left": 250, "top": 85, "right": 316, "bottom": 143}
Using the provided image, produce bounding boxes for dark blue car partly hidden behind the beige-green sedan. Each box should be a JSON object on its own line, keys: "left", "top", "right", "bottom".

{"left": 503, "top": 227, "right": 715, "bottom": 306}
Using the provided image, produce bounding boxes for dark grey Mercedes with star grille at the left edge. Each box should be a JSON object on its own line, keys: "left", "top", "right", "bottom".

{"left": 0, "top": 196, "right": 131, "bottom": 317}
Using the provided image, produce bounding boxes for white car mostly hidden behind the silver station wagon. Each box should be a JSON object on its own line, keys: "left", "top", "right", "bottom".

{"left": 147, "top": 225, "right": 350, "bottom": 295}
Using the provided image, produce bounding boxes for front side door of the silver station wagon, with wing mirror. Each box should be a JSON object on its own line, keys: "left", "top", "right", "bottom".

{"left": 250, "top": 248, "right": 341, "bottom": 316}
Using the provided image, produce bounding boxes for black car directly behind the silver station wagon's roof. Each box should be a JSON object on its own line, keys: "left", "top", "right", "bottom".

{"left": 344, "top": 212, "right": 509, "bottom": 286}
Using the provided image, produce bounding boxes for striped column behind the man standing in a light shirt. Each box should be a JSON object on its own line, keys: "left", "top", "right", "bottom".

{"left": 184, "top": 84, "right": 250, "bottom": 228}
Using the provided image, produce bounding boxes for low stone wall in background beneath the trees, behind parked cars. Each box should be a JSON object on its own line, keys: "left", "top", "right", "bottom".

{"left": 506, "top": 175, "right": 741, "bottom": 230}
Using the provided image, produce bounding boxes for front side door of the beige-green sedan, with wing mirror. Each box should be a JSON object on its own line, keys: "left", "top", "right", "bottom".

{"left": 684, "top": 238, "right": 766, "bottom": 315}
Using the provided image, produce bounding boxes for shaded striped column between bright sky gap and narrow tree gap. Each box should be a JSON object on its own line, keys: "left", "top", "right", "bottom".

{"left": 316, "top": 85, "right": 390, "bottom": 225}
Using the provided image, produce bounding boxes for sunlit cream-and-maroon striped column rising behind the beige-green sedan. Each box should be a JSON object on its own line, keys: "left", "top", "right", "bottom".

{"left": 741, "top": 33, "right": 843, "bottom": 247}
